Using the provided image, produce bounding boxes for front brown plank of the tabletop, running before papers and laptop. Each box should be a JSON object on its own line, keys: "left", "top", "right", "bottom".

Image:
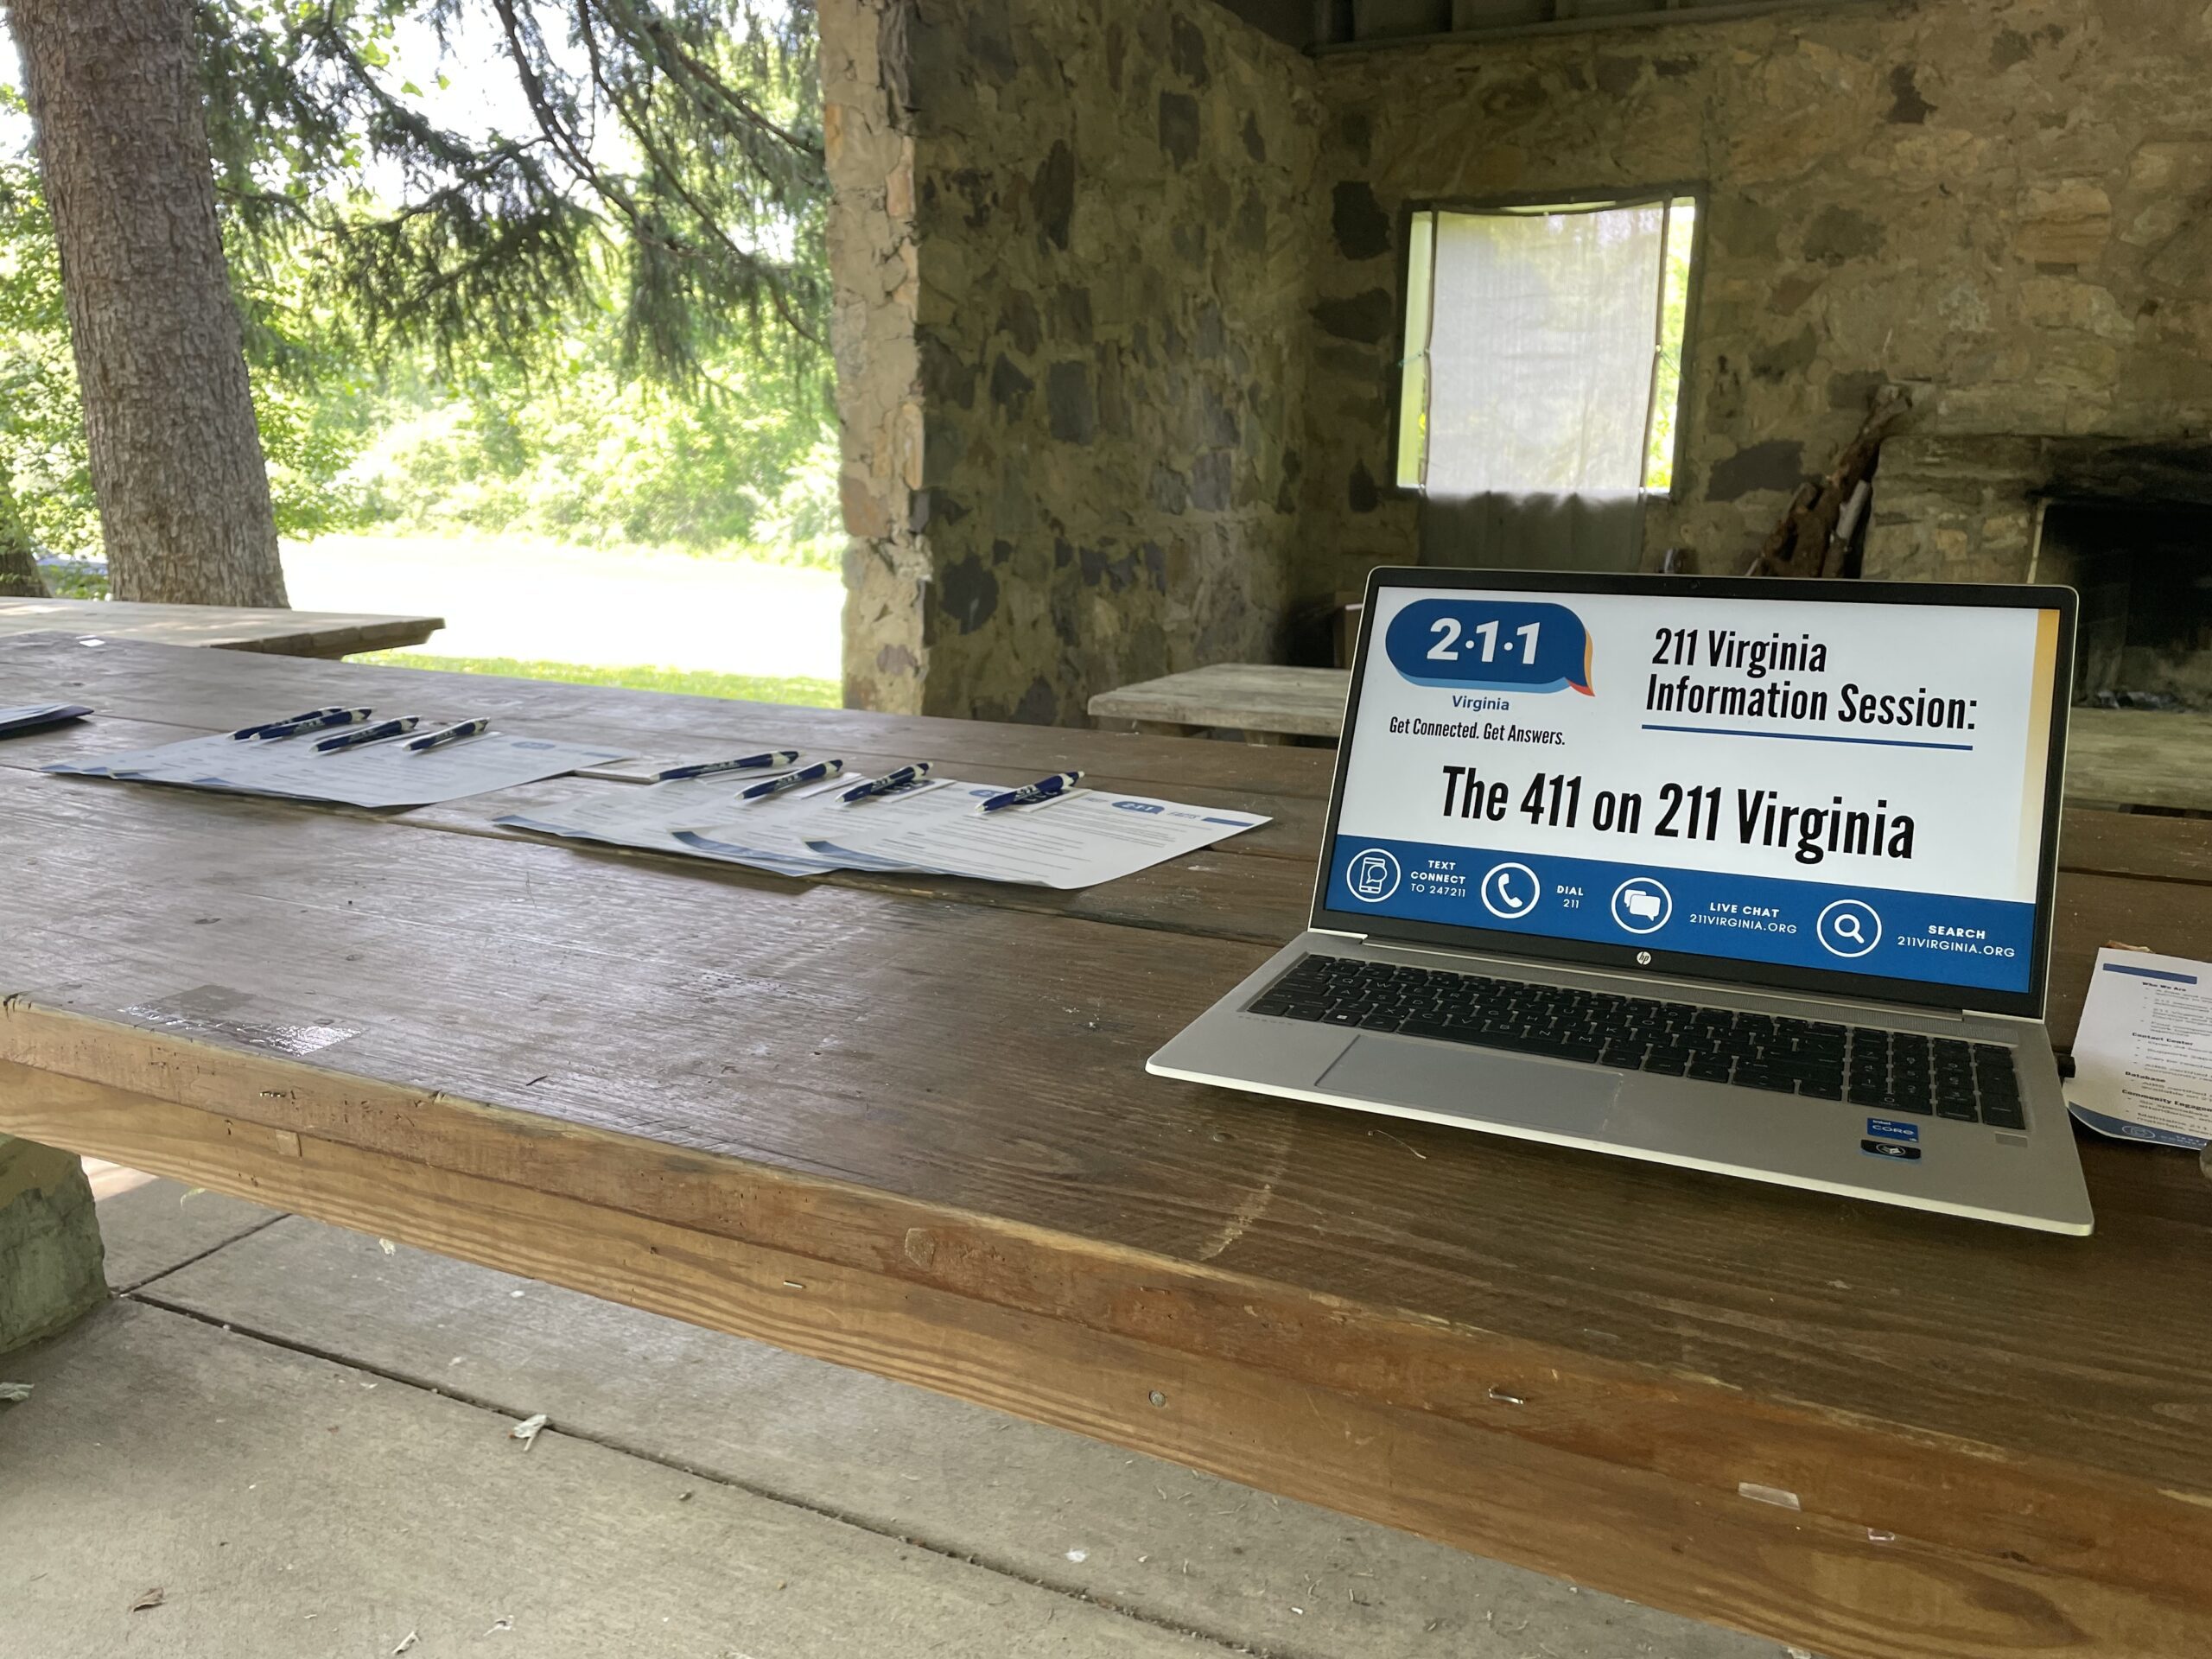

{"left": 0, "top": 781, "right": 2212, "bottom": 1491}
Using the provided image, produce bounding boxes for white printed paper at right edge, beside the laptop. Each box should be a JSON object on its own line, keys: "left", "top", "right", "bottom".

{"left": 2066, "top": 951, "right": 2212, "bottom": 1150}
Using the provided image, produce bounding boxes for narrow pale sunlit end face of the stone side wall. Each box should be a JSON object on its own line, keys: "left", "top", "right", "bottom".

{"left": 817, "top": 0, "right": 929, "bottom": 715}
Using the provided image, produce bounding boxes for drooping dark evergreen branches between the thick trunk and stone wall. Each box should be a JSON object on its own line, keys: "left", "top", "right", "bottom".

{"left": 199, "top": 0, "right": 827, "bottom": 385}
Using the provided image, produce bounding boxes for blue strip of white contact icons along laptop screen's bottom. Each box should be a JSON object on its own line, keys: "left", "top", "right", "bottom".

{"left": 1330, "top": 836, "right": 2035, "bottom": 991}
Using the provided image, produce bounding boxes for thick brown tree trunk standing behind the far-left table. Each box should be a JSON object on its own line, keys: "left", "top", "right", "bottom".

{"left": 9, "top": 0, "right": 285, "bottom": 606}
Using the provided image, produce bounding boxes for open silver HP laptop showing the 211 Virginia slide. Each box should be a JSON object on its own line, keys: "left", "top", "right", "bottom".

{"left": 1148, "top": 570, "right": 2090, "bottom": 1234}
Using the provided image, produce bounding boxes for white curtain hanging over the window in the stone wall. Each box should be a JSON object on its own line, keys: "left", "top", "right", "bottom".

{"left": 1427, "top": 201, "right": 1666, "bottom": 495}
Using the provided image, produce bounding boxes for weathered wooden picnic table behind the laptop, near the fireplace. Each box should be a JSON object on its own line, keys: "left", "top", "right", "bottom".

{"left": 1090, "top": 661, "right": 2212, "bottom": 812}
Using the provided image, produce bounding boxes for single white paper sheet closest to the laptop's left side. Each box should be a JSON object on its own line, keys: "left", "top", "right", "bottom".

{"left": 807, "top": 783, "right": 1268, "bottom": 889}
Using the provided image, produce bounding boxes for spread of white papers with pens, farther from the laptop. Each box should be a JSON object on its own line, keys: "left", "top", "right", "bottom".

{"left": 47, "top": 728, "right": 626, "bottom": 807}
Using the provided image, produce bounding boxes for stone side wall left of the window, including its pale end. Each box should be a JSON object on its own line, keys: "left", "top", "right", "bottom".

{"left": 823, "top": 0, "right": 1320, "bottom": 723}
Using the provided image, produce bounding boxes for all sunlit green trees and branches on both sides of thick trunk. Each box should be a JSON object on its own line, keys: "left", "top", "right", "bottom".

{"left": 0, "top": 0, "right": 841, "bottom": 564}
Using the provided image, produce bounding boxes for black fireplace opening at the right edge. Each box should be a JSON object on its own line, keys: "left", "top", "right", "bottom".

{"left": 2035, "top": 500, "right": 2212, "bottom": 710}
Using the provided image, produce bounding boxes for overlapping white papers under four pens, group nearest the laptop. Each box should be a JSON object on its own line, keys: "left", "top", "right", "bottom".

{"left": 498, "top": 777, "right": 1268, "bottom": 889}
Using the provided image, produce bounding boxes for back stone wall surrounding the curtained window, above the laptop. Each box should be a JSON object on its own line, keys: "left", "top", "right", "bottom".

{"left": 1296, "top": 0, "right": 2212, "bottom": 595}
